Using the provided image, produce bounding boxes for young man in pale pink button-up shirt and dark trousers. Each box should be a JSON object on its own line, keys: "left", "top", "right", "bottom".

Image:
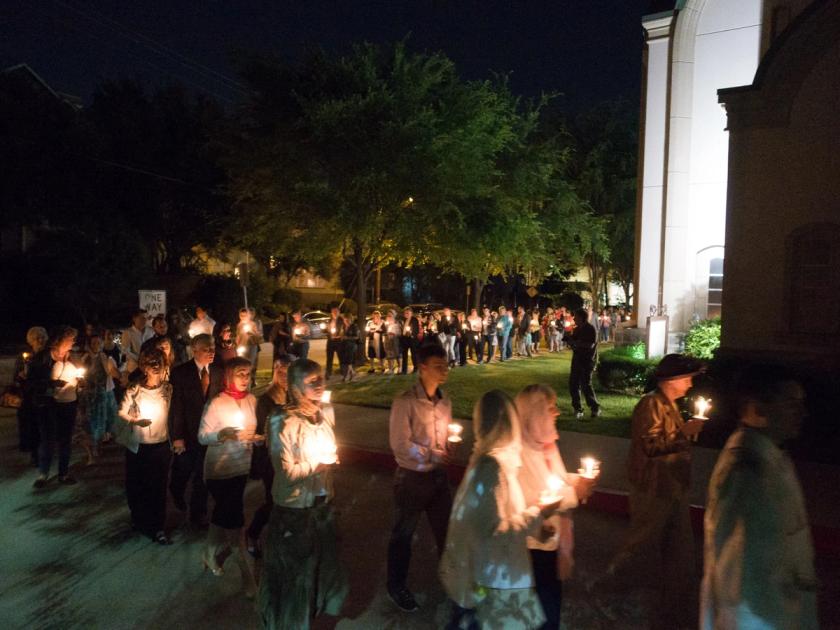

{"left": 387, "top": 343, "right": 457, "bottom": 612}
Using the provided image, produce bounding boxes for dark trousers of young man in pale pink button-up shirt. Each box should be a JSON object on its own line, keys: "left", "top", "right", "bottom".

{"left": 388, "top": 468, "right": 452, "bottom": 589}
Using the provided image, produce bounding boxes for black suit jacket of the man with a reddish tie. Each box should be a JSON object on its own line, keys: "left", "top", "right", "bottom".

{"left": 169, "top": 361, "right": 225, "bottom": 447}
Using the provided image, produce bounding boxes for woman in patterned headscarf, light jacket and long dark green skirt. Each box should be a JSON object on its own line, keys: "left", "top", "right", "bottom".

{"left": 258, "top": 359, "right": 347, "bottom": 630}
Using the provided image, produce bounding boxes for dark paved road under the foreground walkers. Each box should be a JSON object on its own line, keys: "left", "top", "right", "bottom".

{"left": 0, "top": 402, "right": 840, "bottom": 630}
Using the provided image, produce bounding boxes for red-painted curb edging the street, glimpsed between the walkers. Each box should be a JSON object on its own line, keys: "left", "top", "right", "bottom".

{"left": 338, "top": 446, "right": 840, "bottom": 559}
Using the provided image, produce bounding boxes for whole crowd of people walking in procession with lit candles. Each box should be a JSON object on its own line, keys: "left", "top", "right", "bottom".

{"left": 6, "top": 308, "right": 817, "bottom": 629}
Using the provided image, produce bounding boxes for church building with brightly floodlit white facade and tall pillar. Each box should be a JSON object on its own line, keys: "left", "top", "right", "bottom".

{"left": 635, "top": 0, "right": 840, "bottom": 366}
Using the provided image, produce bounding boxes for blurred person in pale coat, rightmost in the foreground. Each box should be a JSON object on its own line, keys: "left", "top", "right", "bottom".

{"left": 700, "top": 366, "right": 819, "bottom": 630}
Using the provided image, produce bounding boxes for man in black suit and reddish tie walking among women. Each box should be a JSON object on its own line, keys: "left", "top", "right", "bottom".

{"left": 168, "top": 333, "right": 224, "bottom": 527}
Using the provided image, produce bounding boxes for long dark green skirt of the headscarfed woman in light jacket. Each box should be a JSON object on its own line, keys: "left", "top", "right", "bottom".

{"left": 258, "top": 503, "right": 348, "bottom": 630}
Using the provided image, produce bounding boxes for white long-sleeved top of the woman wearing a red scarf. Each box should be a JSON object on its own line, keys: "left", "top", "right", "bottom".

{"left": 198, "top": 392, "right": 257, "bottom": 479}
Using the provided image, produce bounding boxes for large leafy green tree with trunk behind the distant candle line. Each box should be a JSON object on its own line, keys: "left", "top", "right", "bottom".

{"left": 225, "top": 42, "right": 536, "bottom": 340}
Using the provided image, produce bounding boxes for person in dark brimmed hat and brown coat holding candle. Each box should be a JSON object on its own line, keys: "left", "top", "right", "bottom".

{"left": 607, "top": 354, "right": 703, "bottom": 630}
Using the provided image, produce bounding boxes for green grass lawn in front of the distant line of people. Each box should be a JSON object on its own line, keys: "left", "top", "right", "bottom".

{"left": 330, "top": 352, "right": 638, "bottom": 437}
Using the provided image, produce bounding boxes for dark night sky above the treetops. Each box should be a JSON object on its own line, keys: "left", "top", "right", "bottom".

{"left": 0, "top": 0, "right": 650, "bottom": 109}
